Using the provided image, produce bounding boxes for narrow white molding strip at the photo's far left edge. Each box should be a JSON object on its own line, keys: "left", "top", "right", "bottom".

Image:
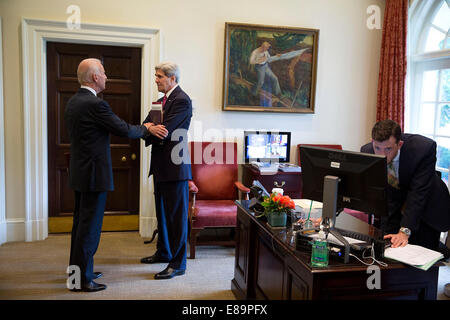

{"left": 0, "top": 17, "right": 7, "bottom": 245}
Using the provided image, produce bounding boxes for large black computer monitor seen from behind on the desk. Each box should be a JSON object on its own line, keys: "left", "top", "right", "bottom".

{"left": 300, "top": 146, "right": 387, "bottom": 218}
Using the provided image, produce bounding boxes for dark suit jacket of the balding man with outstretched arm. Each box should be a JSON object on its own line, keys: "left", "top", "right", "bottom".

{"left": 64, "top": 88, "right": 148, "bottom": 192}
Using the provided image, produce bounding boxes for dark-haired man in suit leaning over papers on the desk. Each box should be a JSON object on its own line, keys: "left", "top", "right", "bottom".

{"left": 361, "top": 120, "right": 450, "bottom": 250}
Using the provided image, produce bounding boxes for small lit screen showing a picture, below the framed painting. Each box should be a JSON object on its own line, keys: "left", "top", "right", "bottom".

{"left": 244, "top": 131, "right": 291, "bottom": 163}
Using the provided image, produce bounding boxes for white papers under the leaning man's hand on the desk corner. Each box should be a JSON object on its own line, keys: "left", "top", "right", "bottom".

{"left": 384, "top": 244, "right": 444, "bottom": 271}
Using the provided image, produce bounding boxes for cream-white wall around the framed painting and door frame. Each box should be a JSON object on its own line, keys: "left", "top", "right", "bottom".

{"left": 0, "top": 0, "right": 384, "bottom": 241}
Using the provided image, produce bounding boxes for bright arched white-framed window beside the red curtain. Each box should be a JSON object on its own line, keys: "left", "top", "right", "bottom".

{"left": 405, "top": 0, "right": 450, "bottom": 183}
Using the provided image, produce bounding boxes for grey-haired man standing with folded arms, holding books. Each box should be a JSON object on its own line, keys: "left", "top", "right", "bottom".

{"left": 141, "top": 62, "right": 192, "bottom": 279}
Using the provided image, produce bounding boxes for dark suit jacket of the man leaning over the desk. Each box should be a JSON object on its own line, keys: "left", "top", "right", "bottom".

{"left": 361, "top": 134, "right": 450, "bottom": 233}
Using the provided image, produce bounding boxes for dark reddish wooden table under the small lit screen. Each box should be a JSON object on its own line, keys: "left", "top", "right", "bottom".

{"left": 242, "top": 164, "right": 302, "bottom": 199}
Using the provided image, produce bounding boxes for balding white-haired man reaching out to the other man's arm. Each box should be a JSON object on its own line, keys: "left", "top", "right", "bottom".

{"left": 64, "top": 59, "right": 164, "bottom": 292}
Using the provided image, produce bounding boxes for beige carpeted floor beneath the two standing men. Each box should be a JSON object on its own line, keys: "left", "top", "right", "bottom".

{"left": 0, "top": 232, "right": 450, "bottom": 300}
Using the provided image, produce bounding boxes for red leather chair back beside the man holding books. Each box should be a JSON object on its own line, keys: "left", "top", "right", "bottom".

{"left": 189, "top": 142, "right": 238, "bottom": 200}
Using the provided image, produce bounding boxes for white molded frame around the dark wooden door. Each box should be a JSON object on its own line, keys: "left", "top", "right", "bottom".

{"left": 21, "top": 18, "right": 162, "bottom": 241}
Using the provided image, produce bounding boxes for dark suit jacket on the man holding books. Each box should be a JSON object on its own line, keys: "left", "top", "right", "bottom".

{"left": 144, "top": 86, "right": 192, "bottom": 182}
